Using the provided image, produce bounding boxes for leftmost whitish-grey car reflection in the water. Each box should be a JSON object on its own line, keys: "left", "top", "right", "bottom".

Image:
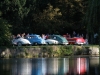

{"left": 11, "top": 58, "right": 33, "bottom": 75}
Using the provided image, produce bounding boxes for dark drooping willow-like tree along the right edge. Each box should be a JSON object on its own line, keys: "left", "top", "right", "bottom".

{"left": 85, "top": 0, "right": 100, "bottom": 44}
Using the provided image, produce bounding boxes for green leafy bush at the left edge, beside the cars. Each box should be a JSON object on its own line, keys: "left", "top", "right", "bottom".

{"left": 0, "top": 18, "right": 11, "bottom": 46}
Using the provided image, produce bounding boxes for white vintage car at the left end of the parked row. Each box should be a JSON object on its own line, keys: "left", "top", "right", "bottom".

{"left": 12, "top": 37, "right": 31, "bottom": 46}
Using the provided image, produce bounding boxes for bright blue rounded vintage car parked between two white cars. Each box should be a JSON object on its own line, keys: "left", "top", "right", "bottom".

{"left": 26, "top": 34, "right": 46, "bottom": 45}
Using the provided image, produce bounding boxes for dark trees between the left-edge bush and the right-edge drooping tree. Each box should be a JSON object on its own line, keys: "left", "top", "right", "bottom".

{"left": 0, "top": 0, "right": 87, "bottom": 34}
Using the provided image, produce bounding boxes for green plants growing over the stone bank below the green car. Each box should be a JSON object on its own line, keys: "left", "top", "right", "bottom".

{"left": 42, "top": 46, "right": 73, "bottom": 57}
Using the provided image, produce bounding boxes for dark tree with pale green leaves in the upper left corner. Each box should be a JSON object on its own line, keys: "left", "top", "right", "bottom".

{"left": 0, "top": 0, "right": 30, "bottom": 33}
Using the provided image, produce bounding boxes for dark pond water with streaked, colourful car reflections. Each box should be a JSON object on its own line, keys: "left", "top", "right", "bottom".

{"left": 0, "top": 57, "right": 100, "bottom": 75}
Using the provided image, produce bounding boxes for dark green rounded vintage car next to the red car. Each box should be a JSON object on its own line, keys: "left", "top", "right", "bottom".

{"left": 48, "top": 35, "right": 68, "bottom": 45}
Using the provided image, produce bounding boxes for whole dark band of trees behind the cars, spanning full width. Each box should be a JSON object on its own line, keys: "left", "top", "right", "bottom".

{"left": 0, "top": 0, "right": 100, "bottom": 45}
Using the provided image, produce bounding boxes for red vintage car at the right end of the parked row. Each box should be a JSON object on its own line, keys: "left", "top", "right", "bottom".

{"left": 64, "top": 35, "right": 86, "bottom": 45}
